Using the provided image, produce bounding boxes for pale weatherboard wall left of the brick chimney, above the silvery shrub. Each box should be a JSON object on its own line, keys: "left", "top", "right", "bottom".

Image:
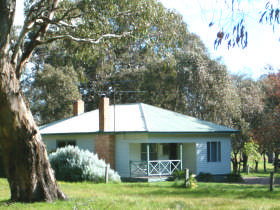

{"left": 42, "top": 134, "right": 95, "bottom": 152}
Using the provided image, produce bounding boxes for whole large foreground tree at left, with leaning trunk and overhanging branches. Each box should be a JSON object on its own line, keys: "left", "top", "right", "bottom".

{"left": 0, "top": 0, "right": 186, "bottom": 202}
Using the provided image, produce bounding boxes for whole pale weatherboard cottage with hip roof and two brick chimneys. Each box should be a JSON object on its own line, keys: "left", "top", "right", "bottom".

{"left": 40, "top": 97, "right": 238, "bottom": 177}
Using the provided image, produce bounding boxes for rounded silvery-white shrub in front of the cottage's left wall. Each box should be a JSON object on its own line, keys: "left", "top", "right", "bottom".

{"left": 49, "top": 145, "right": 120, "bottom": 183}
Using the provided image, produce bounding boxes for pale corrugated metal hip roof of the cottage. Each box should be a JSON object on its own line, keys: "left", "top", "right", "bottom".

{"left": 40, "top": 103, "right": 238, "bottom": 135}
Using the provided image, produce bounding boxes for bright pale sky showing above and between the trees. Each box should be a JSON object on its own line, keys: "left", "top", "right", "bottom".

{"left": 15, "top": 0, "right": 280, "bottom": 79}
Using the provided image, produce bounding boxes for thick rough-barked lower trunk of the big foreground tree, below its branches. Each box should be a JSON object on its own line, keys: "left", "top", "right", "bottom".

{"left": 0, "top": 56, "right": 67, "bottom": 202}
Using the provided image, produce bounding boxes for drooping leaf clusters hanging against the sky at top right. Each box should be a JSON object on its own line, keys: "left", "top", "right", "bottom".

{"left": 209, "top": 0, "right": 280, "bottom": 49}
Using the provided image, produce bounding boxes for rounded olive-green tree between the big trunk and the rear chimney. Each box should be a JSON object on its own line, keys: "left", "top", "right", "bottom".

{"left": 24, "top": 64, "right": 81, "bottom": 124}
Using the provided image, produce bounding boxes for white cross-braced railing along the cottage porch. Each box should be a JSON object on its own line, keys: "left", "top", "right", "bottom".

{"left": 130, "top": 160, "right": 182, "bottom": 177}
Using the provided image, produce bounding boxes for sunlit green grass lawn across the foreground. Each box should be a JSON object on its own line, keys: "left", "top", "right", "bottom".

{"left": 0, "top": 179, "right": 280, "bottom": 209}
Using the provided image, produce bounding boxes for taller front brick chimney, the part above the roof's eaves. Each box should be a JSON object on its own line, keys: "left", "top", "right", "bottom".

{"left": 99, "top": 95, "right": 110, "bottom": 132}
